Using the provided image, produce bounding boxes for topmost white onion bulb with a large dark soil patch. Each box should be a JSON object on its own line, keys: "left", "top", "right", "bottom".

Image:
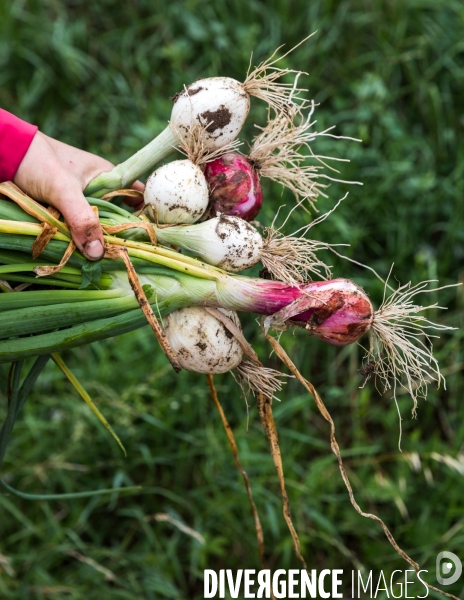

{"left": 171, "top": 77, "right": 250, "bottom": 150}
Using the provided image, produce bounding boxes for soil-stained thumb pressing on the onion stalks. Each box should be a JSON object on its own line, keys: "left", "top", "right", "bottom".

{"left": 53, "top": 192, "right": 105, "bottom": 260}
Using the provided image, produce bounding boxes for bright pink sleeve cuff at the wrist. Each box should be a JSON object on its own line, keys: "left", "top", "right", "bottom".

{"left": 0, "top": 108, "right": 38, "bottom": 182}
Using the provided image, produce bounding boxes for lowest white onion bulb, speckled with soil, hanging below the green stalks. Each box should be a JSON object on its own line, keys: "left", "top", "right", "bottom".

{"left": 164, "top": 306, "right": 243, "bottom": 375}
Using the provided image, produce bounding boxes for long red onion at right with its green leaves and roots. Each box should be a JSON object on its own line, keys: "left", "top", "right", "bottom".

{"left": 0, "top": 184, "right": 448, "bottom": 408}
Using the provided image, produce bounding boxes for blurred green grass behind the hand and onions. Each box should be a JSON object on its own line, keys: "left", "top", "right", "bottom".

{"left": 0, "top": 0, "right": 464, "bottom": 600}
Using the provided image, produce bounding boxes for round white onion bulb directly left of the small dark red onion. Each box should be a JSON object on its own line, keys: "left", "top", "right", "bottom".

{"left": 143, "top": 160, "right": 208, "bottom": 223}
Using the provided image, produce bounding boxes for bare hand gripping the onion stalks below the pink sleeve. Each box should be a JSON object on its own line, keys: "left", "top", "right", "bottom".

{"left": 14, "top": 131, "right": 144, "bottom": 260}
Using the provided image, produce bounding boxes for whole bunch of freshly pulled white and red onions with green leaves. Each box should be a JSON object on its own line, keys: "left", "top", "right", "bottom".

{"left": 0, "top": 38, "right": 456, "bottom": 596}
